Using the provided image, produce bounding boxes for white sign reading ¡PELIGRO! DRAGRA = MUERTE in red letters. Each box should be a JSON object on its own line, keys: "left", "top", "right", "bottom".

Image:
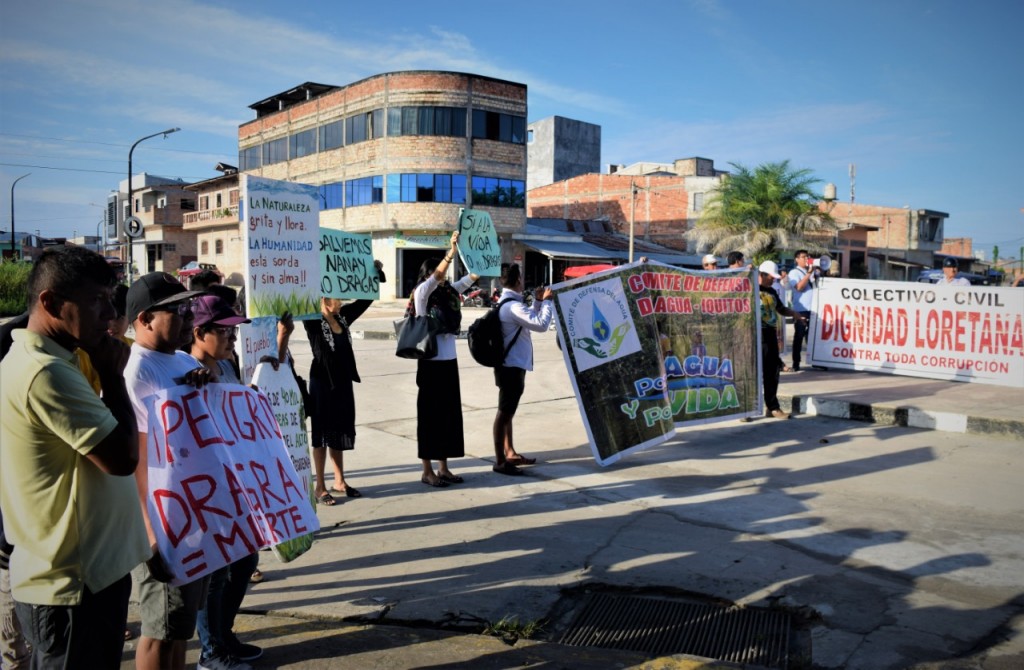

{"left": 146, "top": 384, "right": 319, "bottom": 584}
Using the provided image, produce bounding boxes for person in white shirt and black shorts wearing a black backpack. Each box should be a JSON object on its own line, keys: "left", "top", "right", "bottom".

{"left": 492, "top": 263, "right": 554, "bottom": 475}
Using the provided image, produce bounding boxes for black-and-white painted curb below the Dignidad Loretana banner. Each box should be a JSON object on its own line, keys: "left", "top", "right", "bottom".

{"left": 778, "top": 394, "right": 1024, "bottom": 439}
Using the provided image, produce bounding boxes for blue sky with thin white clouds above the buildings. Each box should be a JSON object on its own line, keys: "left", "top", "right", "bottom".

{"left": 0, "top": 0, "right": 1024, "bottom": 268}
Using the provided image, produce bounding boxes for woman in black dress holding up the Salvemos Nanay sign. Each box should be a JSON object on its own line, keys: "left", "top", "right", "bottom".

{"left": 302, "top": 260, "right": 387, "bottom": 507}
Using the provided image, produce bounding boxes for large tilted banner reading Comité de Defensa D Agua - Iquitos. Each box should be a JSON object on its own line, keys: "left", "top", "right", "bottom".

{"left": 552, "top": 263, "right": 762, "bottom": 465}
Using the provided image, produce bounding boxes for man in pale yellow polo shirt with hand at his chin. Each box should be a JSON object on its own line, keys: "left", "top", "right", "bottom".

{"left": 0, "top": 247, "right": 152, "bottom": 668}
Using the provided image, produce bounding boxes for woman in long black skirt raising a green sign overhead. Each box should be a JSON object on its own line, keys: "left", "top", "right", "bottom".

{"left": 406, "top": 231, "right": 479, "bottom": 488}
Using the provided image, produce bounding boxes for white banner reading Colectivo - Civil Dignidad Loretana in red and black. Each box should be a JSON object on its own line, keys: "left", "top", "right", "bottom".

{"left": 810, "top": 279, "right": 1024, "bottom": 388}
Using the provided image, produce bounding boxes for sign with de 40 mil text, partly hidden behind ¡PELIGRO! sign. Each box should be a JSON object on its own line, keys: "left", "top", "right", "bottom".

{"left": 253, "top": 363, "right": 316, "bottom": 562}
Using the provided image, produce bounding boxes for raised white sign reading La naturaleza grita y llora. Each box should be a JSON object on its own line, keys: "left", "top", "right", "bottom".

{"left": 241, "top": 174, "right": 319, "bottom": 319}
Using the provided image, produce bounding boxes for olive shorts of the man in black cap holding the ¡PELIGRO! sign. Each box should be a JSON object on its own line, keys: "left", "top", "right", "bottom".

{"left": 131, "top": 562, "right": 210, "bottom": 641}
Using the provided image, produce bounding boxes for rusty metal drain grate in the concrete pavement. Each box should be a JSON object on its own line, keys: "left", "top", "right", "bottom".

{"left": 559, "top": 593, "right": 791, "bottom": 670}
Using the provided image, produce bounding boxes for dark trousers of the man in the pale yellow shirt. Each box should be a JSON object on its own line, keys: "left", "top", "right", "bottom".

{"left": 14, "top": 575, "right": 131, "bottom": 670}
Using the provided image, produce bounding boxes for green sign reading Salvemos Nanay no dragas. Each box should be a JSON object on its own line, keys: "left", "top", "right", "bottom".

{"left": 319, "top": 228, "right": 381, "bottom": 300}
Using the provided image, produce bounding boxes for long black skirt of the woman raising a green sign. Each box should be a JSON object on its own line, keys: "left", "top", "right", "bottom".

{"left": 416, "top": 359, "right": 466, "bottom": 461}
